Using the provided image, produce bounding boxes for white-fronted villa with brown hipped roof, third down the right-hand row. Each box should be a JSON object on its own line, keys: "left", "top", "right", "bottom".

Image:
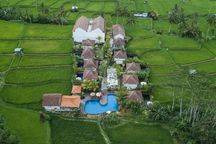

{"left": 113, "top": 50, "right": 127, "bottom": 64}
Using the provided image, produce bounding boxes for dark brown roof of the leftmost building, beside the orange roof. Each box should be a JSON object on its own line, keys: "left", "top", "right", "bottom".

{"left": 42, "top": 93, "right": 62, "bottom": 106}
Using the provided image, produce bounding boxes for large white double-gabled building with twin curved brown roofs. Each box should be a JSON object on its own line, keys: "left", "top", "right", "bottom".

{"left": 73, "top": 16, "right": 105, "bottom": 43}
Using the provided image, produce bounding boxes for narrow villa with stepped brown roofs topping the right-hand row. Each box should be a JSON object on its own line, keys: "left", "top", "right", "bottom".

{"left": 110, "top": 24, "right": 125, "bottom": 50}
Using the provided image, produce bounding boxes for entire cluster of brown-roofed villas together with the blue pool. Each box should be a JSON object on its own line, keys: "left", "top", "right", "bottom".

{"left": 43, "top": 16, "right": 148, "bottom": 114}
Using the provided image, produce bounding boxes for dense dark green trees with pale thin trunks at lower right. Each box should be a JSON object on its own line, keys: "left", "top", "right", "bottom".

{"left": 149, "top": 74, "right": 216, "bottom": 144}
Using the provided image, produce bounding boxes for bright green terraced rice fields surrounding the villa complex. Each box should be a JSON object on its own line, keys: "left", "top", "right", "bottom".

{"left": 0, "top": 0, "right": 216, "bottom": 144}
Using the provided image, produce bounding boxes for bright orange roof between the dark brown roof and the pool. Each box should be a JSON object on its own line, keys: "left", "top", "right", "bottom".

{"left": 61, "top": 95, "right": 81, "bottom": 108}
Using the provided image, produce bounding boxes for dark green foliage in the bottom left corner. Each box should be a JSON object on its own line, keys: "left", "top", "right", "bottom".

{"left": 0, "top": 115, "right": 19, "bottom": 144}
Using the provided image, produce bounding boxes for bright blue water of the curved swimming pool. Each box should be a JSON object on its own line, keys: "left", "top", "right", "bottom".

{"left": 84, "top": 94, "right": 118, "bottom": 115}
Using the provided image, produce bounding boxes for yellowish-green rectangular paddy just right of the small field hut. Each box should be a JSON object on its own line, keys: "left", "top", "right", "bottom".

{"left": 20, "top": 40, "right": 73, "bottom": 53}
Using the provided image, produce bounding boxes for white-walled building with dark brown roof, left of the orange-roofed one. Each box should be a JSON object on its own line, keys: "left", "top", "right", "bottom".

{"left": 42, "top": 93, "right": 62, "bottom": 111}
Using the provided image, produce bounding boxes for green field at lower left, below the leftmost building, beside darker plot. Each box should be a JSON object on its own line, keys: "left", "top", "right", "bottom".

{"left": 0, "top": 104, "right": 50, "bottom": 144}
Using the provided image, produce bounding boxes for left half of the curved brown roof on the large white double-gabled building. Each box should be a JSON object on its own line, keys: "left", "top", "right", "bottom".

{"left": 73, "top": 16, "right": 89, "bottom": 32}
